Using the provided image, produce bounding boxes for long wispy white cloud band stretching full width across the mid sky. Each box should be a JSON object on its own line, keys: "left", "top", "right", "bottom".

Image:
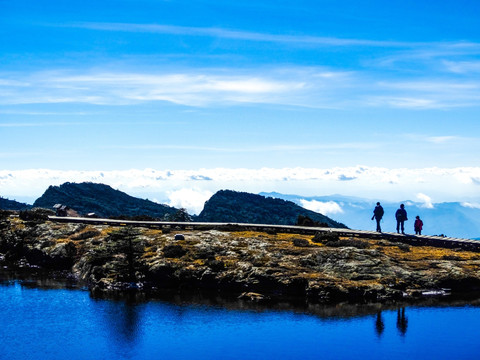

{"left": 0, "top": 67, "right": 480, "bottom": 109}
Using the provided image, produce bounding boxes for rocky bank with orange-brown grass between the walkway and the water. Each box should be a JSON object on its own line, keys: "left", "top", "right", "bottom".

{"left": 0, "top": 217, "right": 480, "bottom": 302}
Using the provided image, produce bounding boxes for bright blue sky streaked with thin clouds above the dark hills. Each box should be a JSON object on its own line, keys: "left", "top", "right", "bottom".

{"left": 0, "top": 0, "right": 480, "bottom": 210}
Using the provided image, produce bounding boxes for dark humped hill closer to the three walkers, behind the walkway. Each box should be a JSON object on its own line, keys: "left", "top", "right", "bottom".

{"left": 196, "top": 190, "right": 346, "bottom": 228}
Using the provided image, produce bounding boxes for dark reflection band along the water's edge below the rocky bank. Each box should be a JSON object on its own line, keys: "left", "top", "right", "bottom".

{"left": 0, "top": 268, "right": 480, "bottom": 319}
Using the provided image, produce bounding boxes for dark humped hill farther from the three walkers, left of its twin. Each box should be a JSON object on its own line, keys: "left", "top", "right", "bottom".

{"left": 33, "top": 182, "right": 177, "bottom": 218}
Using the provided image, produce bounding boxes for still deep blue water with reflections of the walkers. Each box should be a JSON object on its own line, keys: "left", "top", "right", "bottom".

{"left": 0, "top": 281, "right": 480, "bottom": 360}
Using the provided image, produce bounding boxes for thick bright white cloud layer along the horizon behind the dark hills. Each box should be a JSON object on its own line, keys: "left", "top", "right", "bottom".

{"left": 0, "top": 166, "right": 480, "bottom": 214}
